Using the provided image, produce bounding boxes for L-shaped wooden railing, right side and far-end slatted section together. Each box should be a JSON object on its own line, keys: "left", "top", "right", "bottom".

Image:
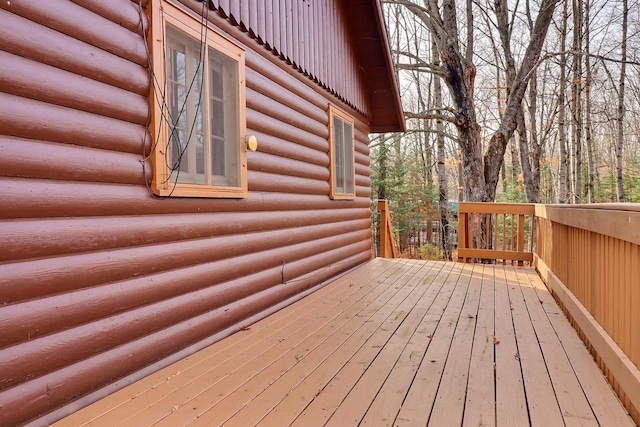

{"left": 458, "top": 203, "right": 640, "bottom": 425}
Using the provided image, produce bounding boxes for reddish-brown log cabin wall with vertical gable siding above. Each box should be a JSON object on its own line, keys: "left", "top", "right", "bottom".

{"left": 0, "top": 0, "right": 390, "bottom": 425}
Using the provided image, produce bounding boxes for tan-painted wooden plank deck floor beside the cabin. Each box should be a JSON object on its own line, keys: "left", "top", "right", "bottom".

{"left": 57, "top": 258, "right": 634, "bottom": 427}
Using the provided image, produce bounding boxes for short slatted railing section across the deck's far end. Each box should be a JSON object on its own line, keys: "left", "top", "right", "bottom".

{"left": 458, "top": 203, "right": 535, "bottom": 263}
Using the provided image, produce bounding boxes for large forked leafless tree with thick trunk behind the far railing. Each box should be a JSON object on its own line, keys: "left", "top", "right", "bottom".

{"left": 393, "top": 0, "right": 557, "bottom": 201}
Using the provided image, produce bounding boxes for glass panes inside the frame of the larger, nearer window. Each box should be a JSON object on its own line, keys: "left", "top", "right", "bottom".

{"left": 166, "top": 25, "right": 240, "bottom": 187}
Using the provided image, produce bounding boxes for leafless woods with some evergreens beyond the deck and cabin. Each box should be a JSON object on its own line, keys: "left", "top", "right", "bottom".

{"left": 371, "top": 0, "right": 640, "bottom": 256}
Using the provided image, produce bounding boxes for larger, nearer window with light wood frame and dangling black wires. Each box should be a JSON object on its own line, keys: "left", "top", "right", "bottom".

{"left": 153, "top": 2, "right": 247, "bottom": 197}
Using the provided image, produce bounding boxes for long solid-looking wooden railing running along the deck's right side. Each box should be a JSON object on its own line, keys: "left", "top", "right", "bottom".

{"left": 535, "top": 205, "right": 640, "bottom": 425}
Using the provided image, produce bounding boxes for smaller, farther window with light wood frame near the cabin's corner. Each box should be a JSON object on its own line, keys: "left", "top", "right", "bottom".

{"left": 329, "top": 105, "right": 356, "bottom": 199}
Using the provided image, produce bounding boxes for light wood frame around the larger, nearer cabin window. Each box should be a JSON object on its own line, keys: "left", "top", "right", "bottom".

{"left": 150, "top": 0, "right": 249, "bottom": 198}
